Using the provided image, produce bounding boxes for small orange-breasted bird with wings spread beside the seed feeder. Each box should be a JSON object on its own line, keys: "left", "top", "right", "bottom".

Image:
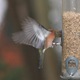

{"left": 12, "top": 17, "right": 61, "bottom": 68}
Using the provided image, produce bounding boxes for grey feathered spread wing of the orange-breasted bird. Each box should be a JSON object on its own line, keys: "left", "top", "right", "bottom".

{"left": 12, "top": 17, "right": 50, "bottom": 48}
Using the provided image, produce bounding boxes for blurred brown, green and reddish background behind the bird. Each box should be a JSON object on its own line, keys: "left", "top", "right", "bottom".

{"left": 0, "top": 0, "right": 62, "bottom": 80}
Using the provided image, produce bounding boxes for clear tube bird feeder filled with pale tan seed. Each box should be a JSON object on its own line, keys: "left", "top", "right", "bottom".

{"left": 61, "top": 0, "right": 80, "bottom": 80}
